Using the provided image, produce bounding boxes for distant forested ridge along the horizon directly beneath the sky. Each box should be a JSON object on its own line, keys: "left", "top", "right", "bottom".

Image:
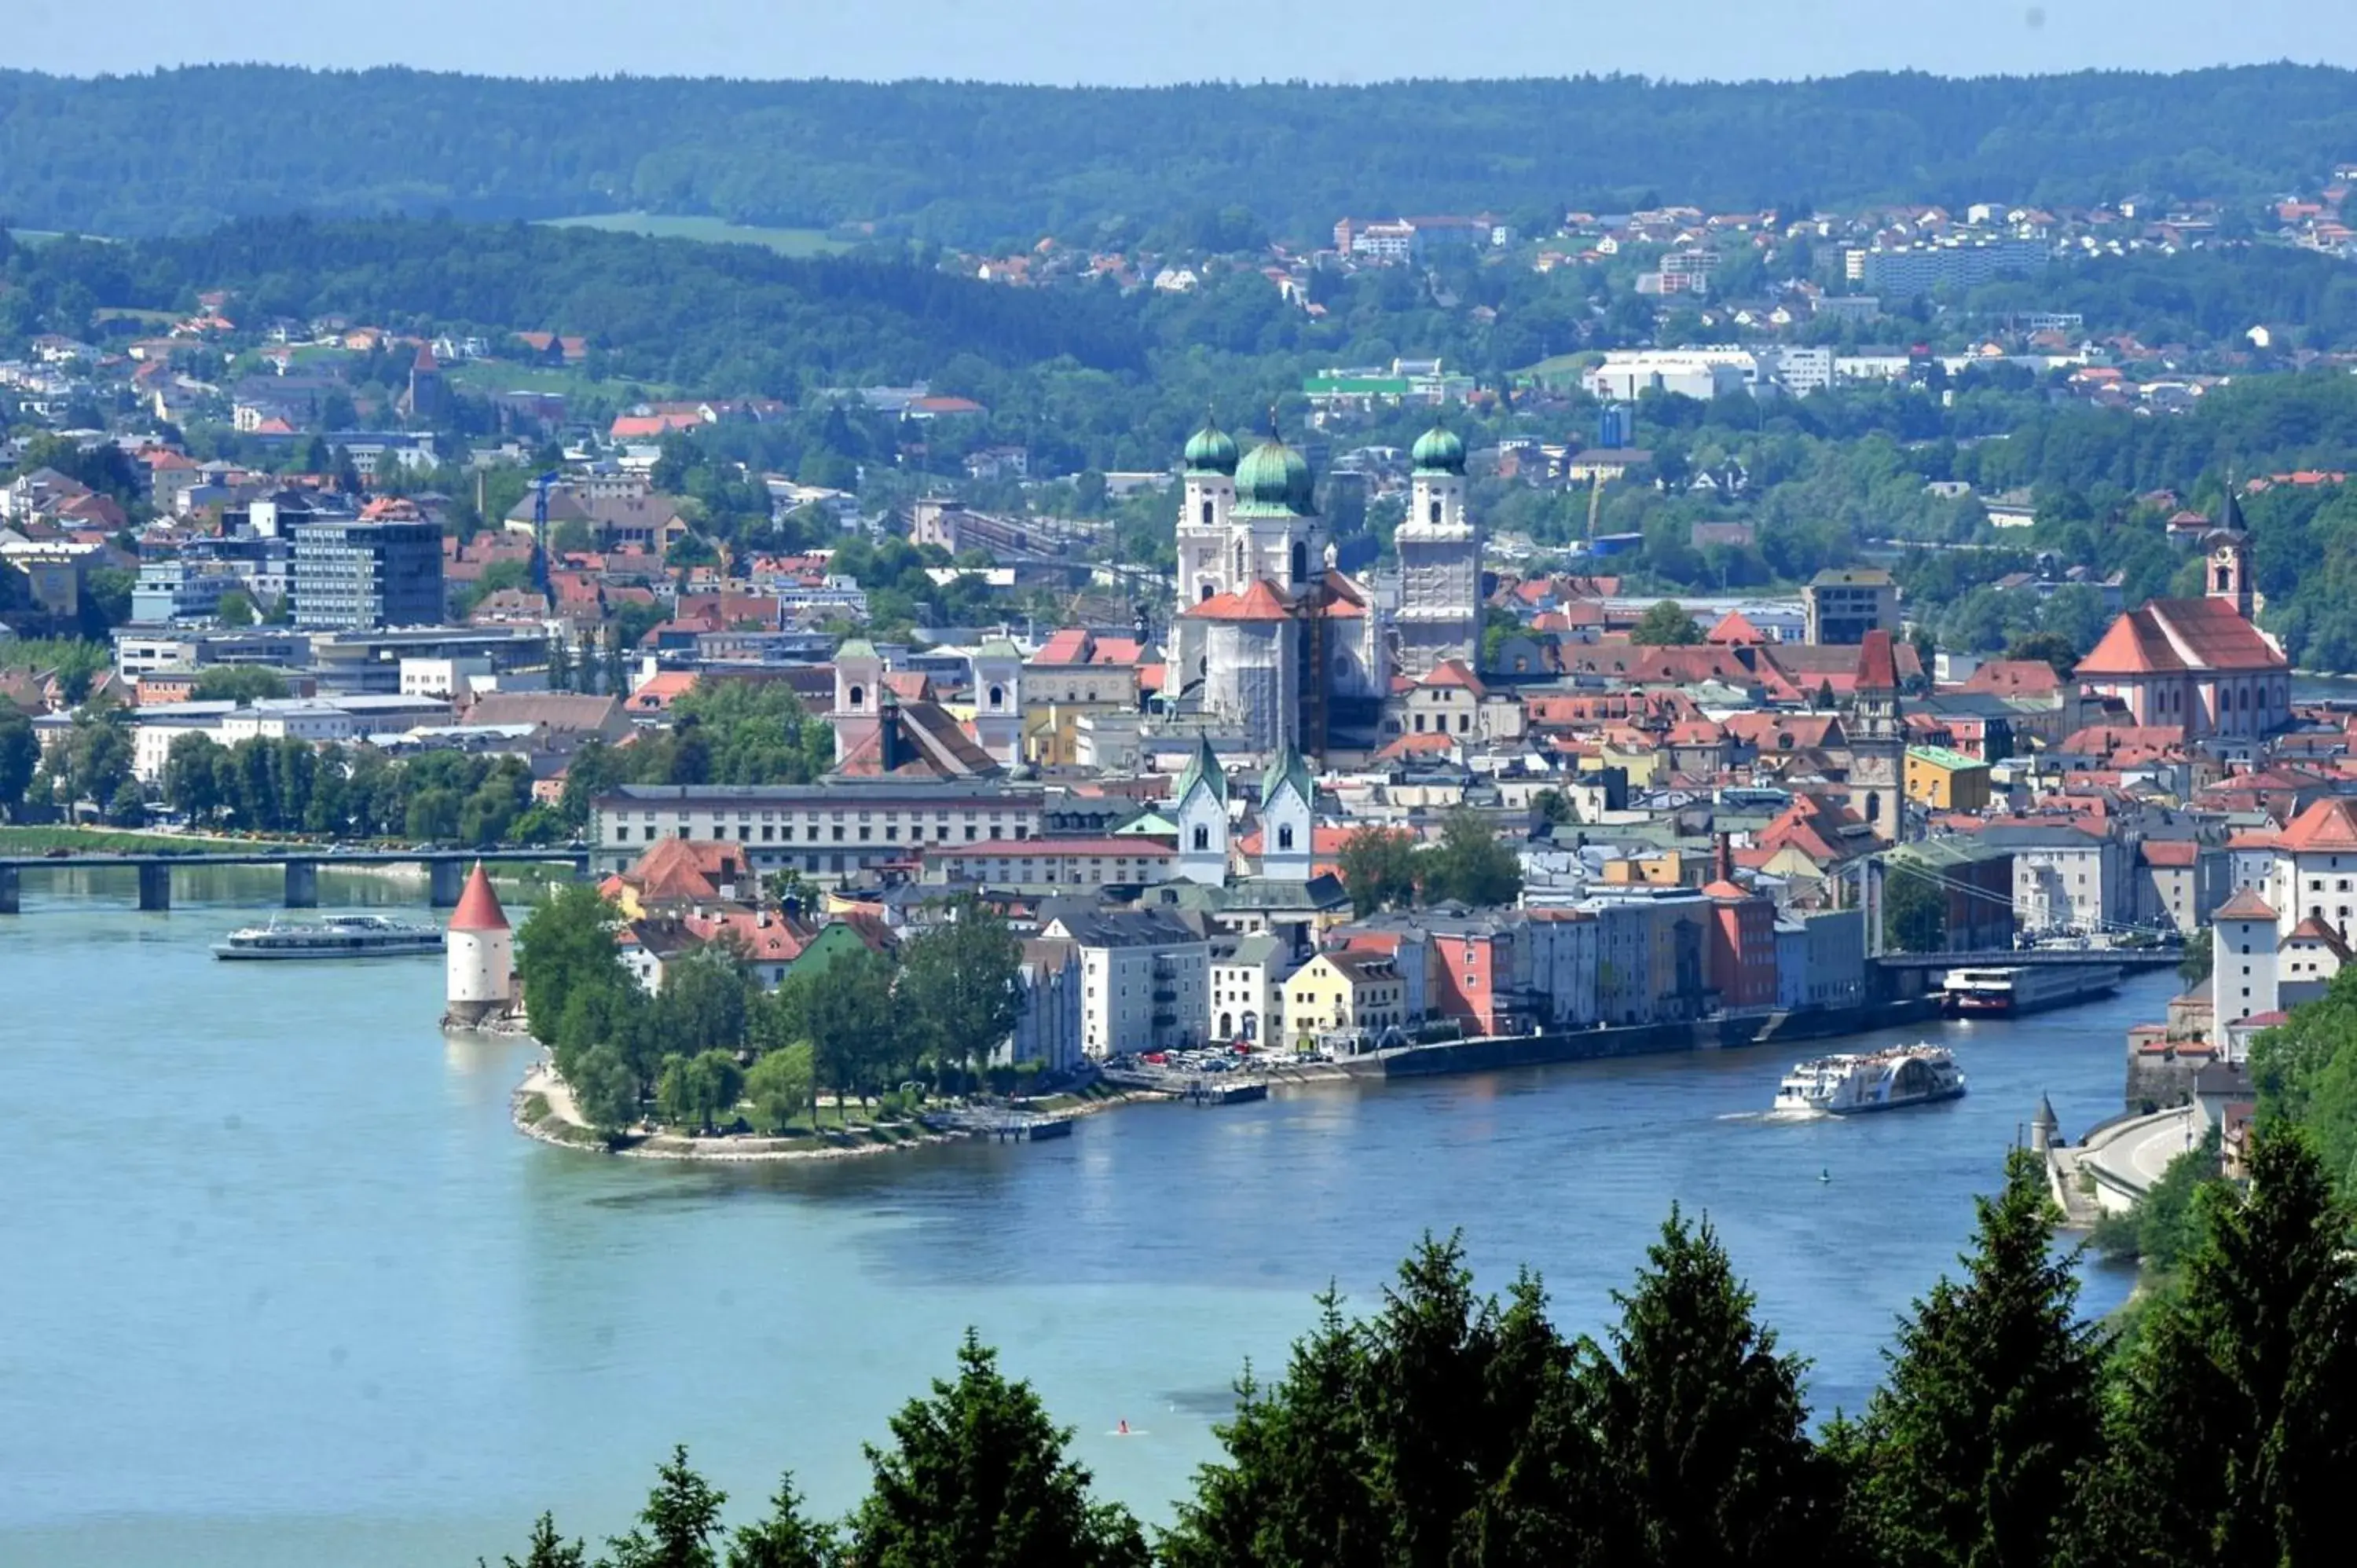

{"left": 0, "top": 66, "right": 2357, "bottom": 243}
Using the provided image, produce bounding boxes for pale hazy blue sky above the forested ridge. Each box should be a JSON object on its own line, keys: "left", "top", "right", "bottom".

{"left": 13, "top": 0, "right": 2357, "bottom": 82}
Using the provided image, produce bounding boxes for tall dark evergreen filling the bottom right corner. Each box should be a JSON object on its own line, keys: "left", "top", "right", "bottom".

{"left": 2081, "top": 1130, "right": 2357, "bottom": 1566}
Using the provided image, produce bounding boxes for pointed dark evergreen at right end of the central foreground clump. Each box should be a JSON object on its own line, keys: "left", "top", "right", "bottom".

{"left": 1584, "top": 1207, "right": 1831, "bottom": 1568}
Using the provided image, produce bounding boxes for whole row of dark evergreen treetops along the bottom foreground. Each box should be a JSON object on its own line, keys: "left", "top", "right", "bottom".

{"left": 507, "top": 1137, "right": 2357, "bottom": 1568}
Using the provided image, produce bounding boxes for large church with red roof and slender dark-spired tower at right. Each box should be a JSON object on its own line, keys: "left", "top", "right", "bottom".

{"left": 2077, "top": 495, "right": 2291, "bottom": 738}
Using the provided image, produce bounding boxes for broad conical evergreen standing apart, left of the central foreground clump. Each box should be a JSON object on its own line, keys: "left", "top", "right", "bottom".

{"left": 851, "top": 1330, "right": 1148, "bottom": 1568}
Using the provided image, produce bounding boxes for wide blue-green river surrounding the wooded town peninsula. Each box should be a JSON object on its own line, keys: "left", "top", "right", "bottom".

{"left": 0, "top": 873, "right": 2171, "bottom": 1568}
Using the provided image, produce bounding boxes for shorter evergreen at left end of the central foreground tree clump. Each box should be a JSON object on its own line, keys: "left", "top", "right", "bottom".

{"left": 1162, "top": 1288, "right": 1386, "bottom": 1568}
